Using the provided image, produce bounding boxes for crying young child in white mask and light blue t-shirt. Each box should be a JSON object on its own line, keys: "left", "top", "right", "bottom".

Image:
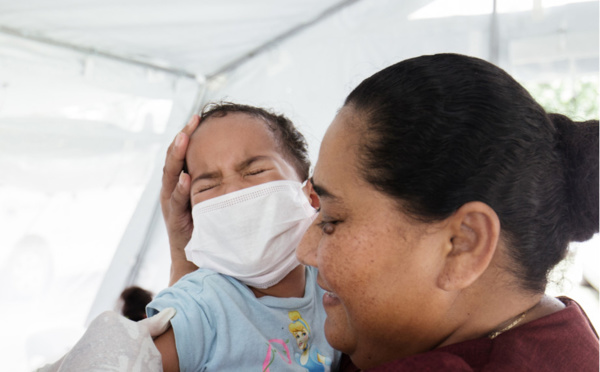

{"left": 147, "top": 104, "right": 340, "bottom": 372}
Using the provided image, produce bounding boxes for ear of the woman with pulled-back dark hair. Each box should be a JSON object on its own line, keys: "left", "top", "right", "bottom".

{"left": 438, "top": 202, "right": 500, "bottom": 291}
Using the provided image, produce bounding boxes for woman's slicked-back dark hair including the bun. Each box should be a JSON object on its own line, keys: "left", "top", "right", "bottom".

{"left": 345, "top": 54, "right": 598, "bottom": 292}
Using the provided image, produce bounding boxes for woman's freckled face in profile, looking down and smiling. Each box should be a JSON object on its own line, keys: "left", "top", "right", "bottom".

{"left": 298, "top": 107, "right": 452, "bottom": 368}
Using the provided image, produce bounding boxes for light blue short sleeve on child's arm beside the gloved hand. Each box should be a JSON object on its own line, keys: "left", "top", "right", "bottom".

{"left": 146, "top": 278, "right": 216, "bottom": 371}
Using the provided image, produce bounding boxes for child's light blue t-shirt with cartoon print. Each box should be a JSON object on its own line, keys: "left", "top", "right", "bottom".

{"left": 146, "top": 267, "right": 341, "bottom": 372}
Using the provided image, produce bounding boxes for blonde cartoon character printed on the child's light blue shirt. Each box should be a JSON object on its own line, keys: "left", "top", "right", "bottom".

{"left": 288, "top": 311, "right": 331, "bottom": 372}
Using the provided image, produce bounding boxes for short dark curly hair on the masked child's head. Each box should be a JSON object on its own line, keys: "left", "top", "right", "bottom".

{"left": 200, "top": 102, "right": 310, "bottom": 181}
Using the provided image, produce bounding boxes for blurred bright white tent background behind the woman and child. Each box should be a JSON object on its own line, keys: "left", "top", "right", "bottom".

{"left": 0, "top": 0, "right": 600, "bottom": 371}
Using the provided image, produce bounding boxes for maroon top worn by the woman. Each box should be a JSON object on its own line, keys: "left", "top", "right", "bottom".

{"left": 347, "top": 297, "right": 599, "bottom": 372}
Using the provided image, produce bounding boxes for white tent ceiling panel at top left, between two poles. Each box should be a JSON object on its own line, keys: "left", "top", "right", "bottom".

{"left": 0, "top": 0, "right": 346, "bottom": 75}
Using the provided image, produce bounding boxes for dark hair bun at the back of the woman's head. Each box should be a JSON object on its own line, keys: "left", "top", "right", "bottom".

{"left": 548, "top": 114, "right": 599, "bottom": 241}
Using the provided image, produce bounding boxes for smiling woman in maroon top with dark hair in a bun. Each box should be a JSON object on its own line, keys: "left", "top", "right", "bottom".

{"left": 297, "top": 54, "right": 598, "bottom": 371}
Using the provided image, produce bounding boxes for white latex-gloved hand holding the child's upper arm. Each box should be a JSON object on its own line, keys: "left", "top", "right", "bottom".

{"left": 38, "top": 308, "right": 175, "bottom": 372}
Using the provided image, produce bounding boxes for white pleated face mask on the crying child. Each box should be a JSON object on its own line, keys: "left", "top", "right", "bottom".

{"left": 185, "top": 181, "right": 317, "bottom": 288}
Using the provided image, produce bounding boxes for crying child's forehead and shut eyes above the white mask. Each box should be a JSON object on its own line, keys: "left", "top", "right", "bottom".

{"left": 186, "top": 113, "right": 302, "bottom": 205}
